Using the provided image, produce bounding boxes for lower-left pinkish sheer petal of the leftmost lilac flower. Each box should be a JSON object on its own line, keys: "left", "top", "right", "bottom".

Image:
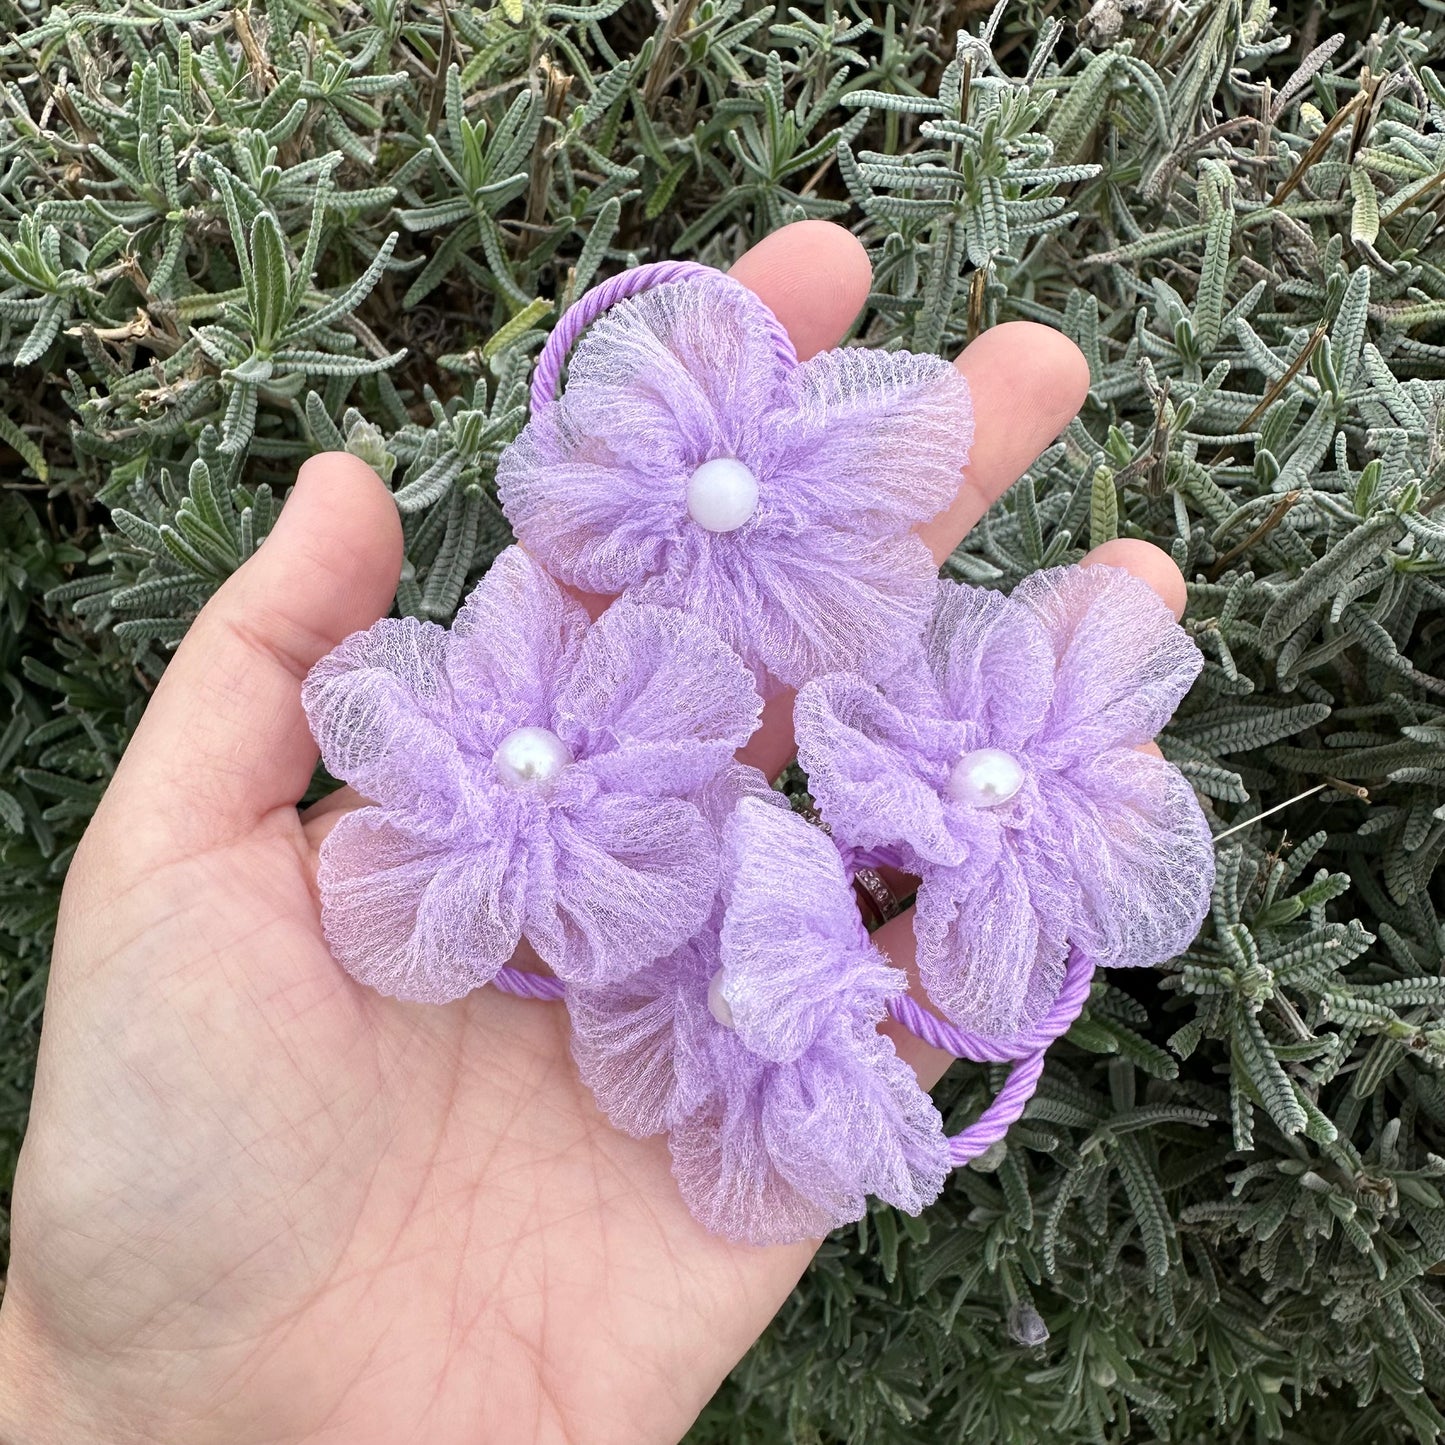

{"left": 318, "top": 808, "right": 526, "bottom": 1003}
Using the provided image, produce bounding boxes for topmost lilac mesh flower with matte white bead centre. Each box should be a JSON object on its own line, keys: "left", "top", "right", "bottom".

{"left": 497, "top": 275, "right": 972, "bottom": 685}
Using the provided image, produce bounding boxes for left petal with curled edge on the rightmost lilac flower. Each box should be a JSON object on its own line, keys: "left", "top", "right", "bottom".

{"left": 793, "top": 673, "right": 970, "bottom": 866}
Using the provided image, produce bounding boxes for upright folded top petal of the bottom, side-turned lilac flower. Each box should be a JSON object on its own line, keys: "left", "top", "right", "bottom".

{"left": 718, "top": 801, "right": 907, "bottom": 1064}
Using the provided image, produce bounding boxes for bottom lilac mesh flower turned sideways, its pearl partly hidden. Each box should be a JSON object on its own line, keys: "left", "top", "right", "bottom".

{"left": 566, "top": 799, "right": 949, "bottom": 1244}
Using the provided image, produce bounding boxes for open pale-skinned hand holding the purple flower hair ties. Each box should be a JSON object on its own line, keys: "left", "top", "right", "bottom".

{"left": 0, "top": 223, "right": 1183, "bottom": 1445}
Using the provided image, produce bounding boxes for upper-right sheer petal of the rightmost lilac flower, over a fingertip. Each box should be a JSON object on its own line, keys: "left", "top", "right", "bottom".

{"left": 1012, "top": 566, "right": 1204, "bottom": 762}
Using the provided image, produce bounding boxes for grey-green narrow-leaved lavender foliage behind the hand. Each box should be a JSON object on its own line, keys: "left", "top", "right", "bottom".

{"left": 0, "top": 0, "right": 1445, "bottom": 1445}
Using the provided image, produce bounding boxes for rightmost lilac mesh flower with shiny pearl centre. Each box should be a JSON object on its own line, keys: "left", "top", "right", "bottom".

{"left": 796, "top": 566, "right": 1214, "bottom": 1038}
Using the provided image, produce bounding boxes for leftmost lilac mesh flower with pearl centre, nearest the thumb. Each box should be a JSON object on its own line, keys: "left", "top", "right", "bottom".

{"left": 302, "top": 548, "right": 760, "bottom": 1003}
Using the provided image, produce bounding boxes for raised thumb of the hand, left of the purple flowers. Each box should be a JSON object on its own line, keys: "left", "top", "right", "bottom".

{"left": 98, "top": 452, "right": 402, "bottom": 857}
